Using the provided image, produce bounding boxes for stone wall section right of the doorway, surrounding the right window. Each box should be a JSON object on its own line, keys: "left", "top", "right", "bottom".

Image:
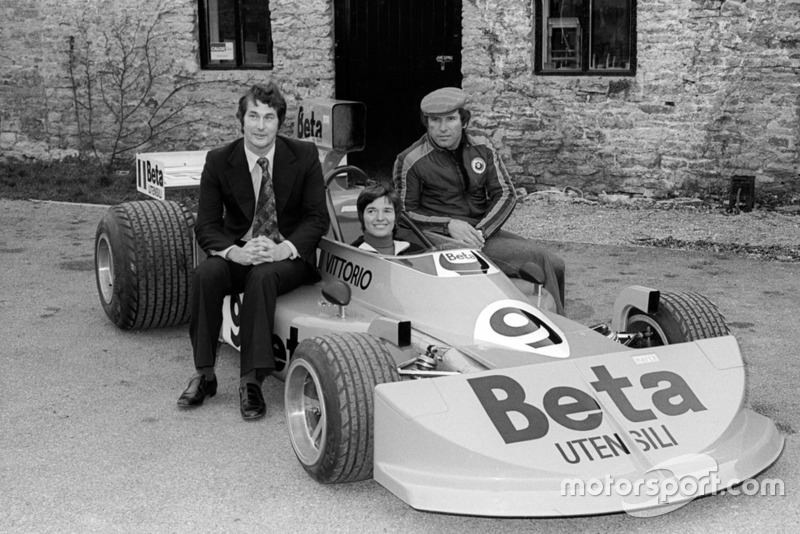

{"left": 463, "top": 0, "right": 800, "bottom": 195}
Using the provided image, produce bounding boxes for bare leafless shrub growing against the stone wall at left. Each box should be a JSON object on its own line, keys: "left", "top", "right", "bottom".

{"left": 67, "top": 2, "right": 244, "bottom": 169}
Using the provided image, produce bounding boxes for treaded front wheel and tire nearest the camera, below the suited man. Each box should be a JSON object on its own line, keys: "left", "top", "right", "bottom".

{"left": 285, "top": 333, "right": 400, "bottom": 484}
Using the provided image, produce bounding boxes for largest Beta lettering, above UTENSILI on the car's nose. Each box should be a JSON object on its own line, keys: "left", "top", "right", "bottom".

{"left": 467, "top": 365, "right": 706, "bottom": 443}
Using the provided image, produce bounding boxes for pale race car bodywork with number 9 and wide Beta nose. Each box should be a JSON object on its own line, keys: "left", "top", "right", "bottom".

{"left": 216, "top": 182, "right": 783, "bottom": 517}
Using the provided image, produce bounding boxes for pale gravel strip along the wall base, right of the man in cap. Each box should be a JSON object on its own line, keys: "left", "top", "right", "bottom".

{"left": 504, "top": 194, "right": 800, "bottom": 262}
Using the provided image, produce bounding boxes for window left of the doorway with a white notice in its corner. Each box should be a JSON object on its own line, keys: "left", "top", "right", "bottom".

{"left": 198, "top": 0, "right": 272, "bottom": 69}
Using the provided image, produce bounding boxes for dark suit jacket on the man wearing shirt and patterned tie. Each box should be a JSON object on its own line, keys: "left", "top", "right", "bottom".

{"left": 195, "top": 135, "right": 330, "bottom": 265}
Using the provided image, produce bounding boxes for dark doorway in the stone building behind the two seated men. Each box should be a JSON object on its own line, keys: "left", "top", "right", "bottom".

{"left": 333, "top": 0, "right": 461, "bottom": 178}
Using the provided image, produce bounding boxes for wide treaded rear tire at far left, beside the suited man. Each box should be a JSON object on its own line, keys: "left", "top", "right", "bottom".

{"left": 95, "top": 200, "right": 194, "bottom": 330}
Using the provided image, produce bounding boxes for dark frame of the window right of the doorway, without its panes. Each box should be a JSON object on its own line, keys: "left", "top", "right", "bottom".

{"left": 532, "top": 0, "right": 638, "bottom": 76}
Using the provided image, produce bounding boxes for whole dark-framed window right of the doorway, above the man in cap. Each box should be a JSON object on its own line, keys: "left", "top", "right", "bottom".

{"left": 534, "top": 0, "right": 636, "bottom": 76}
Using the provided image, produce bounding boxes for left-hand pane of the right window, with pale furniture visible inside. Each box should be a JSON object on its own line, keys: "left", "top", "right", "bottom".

{"left": 542, "top": 0, "right": 584, "bottom": 70}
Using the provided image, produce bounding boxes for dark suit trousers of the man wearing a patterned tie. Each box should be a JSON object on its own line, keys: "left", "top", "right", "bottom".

{"left": 189, "top": 256, "right": 316, "bottom": 376}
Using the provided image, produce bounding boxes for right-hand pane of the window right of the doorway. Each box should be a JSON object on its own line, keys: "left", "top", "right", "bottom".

{"left": 589, "top": 0, "right": 632, "bottom": 70}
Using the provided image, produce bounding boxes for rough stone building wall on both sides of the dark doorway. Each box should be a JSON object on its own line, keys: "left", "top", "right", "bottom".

{"left": 0, "top": 0, "right": 800, "bottom": 196}
